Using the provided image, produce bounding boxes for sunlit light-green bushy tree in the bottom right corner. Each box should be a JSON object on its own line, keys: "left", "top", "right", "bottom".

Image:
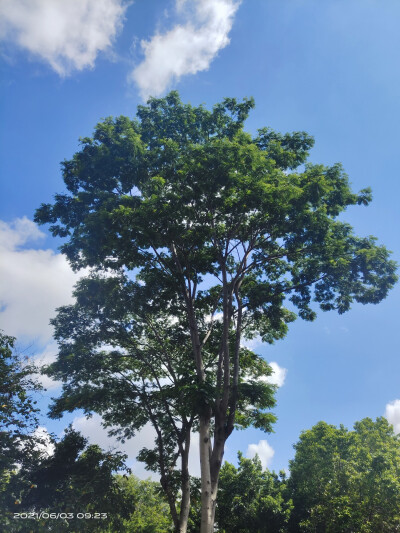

{"left": 289, "top": 418, "right": 400, "bottom": 533}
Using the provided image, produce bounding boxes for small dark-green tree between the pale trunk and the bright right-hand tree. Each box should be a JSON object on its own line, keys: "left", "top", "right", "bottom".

{"left": 216, "top": 453, "right": 292, "bottom": 533}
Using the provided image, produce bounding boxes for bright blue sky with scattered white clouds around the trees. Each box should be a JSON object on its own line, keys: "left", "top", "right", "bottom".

{"left": 0, "top": 0, "right": 400, "bottom": 474}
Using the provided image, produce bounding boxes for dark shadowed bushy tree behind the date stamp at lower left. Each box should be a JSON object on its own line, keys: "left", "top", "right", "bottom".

{"left": 4, "top": 428, "right": 135, "bottom": 532}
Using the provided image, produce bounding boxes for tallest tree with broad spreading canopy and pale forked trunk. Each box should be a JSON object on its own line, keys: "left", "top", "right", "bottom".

{"left": 35, "top": 92, "right": 396, "bottom": 533}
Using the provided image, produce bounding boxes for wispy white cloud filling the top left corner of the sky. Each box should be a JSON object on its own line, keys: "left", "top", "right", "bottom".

{"left": 0, "top": 0, "right": 127, "bottom": 76}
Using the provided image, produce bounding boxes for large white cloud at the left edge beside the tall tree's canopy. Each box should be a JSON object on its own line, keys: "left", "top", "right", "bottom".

{"left": 0, "top": 217, "right": 82, "bottom": 344}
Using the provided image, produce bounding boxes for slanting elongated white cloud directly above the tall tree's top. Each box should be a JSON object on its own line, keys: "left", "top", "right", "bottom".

{"left": 130, "top": 0, "right": 240, "bottom": 99}
